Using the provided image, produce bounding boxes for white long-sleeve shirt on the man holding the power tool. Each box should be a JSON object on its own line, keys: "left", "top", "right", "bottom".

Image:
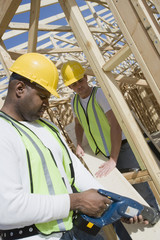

{"left": 0, "top": 118, "right": 102, "bottom": 240}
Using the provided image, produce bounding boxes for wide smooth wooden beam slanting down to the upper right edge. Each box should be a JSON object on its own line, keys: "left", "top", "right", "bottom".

{"left": 106, "top": 0, "right": 160, "bottom": 104}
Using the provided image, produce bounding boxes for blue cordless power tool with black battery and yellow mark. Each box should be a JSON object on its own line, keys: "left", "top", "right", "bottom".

{"left": 74, "top": 189, "right": 160, "bottom": 235}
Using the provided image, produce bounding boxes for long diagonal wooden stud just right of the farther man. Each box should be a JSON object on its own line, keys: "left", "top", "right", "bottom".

{"left": 59, "top": 0, "right": 160, "bottom": 193}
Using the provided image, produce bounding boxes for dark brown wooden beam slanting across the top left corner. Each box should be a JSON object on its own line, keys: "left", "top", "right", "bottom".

{"left": 0, "top": 0, "right": 21, "bottom": 38}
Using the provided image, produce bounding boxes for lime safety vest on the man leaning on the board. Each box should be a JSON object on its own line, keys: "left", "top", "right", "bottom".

{"left": 73, "top": 87, "right": 111, "bottom": 157}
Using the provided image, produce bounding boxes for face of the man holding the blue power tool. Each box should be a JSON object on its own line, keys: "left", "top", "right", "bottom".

{"left": 18, "top": 80, "right": 50, "bottom": 122}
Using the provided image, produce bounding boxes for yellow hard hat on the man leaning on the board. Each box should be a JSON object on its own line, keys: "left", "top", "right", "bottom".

{"left": 61, "top": 61, "right": 85, "bottom": 86}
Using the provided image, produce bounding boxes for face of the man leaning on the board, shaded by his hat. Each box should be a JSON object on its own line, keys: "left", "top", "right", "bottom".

{"left": 69, "top": 75, "right": 90, "bottom": 98}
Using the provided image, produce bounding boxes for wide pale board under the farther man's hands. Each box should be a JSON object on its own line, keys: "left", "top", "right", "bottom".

{"left": 65, "top": 123, "right": 160, "bottom": 240}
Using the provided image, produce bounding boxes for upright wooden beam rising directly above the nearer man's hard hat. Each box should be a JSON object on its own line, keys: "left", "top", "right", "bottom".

{"left": 28, "top": 0, "right": 41, "bottom": 52}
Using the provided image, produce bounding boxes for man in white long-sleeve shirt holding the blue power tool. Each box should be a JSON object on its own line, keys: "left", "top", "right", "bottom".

{"left": 0, "top": 53, "right": 148, "bottom": 240}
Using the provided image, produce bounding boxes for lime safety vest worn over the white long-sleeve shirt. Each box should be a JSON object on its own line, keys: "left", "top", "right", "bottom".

{"left": 0, "top": 112, "right": 78, "bottom": 235}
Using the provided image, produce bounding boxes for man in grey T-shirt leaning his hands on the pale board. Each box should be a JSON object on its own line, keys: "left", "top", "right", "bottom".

{"left": 61, "top": 61, "right": 158, "bottom": 240}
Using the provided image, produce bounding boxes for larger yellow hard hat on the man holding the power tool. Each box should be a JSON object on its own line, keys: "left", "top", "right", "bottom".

{"left": 9, "top": 53, "right": 59, "bottom": 97}
